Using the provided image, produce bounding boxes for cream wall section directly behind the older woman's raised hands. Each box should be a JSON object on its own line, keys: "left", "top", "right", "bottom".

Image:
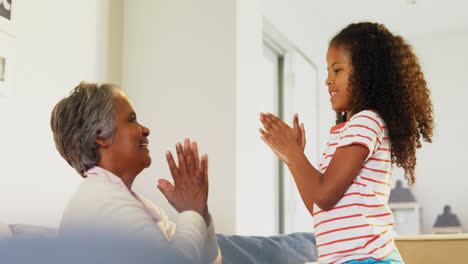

{"left": 122, "top": 0, "right": 236, "bottom": 234}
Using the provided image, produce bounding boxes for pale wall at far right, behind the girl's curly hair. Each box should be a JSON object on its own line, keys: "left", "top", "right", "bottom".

{"left": 409, "top": 29, "right": 468, "bottom": 232}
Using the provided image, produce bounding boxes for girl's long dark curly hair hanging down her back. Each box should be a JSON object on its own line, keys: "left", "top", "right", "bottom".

{"left": 330, "top": 22, "right": 434, "bottom": 184}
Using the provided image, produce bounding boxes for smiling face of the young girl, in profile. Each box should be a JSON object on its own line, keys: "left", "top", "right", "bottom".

{"left": 325, "top": 45, "right": 353, "bottom": 117}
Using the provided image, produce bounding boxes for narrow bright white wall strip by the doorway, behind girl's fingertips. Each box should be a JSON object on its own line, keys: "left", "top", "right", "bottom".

{"left": 236, "top": 0, "right": 278, "bottom": 235}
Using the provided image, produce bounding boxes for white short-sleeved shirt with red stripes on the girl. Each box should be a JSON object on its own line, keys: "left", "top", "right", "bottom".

{"left": 313, "top": 110, "right": 395, "bottom": 264}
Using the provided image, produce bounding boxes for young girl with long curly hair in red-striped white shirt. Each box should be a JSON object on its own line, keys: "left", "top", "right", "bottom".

{"left": 260, "top": 23, "right": 433, "bottom": 264}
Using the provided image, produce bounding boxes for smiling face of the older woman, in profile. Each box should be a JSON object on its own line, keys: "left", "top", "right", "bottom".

{"left": 107, "top": 95, "right": 151, "bottom": 174}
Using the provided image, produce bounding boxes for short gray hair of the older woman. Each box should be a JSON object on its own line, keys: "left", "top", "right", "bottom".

{"left": 50, "top": 82, "right": 123, "bottom": 176}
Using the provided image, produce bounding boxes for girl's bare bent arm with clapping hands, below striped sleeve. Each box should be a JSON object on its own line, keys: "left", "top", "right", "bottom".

{"left": 260, "top": 114, "right": 369, "bottom": 213}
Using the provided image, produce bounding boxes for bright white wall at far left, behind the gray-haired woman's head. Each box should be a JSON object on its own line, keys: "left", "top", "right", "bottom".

{"left": 0, "top": 0, "right": 115, "bottom": 227}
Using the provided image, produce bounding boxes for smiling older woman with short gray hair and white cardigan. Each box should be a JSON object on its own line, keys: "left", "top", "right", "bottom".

{"left": 51, "top": 82, "right": 221, "bottom": 263}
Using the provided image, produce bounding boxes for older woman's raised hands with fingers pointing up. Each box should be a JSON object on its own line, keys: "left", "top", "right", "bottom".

{"left": 158, "top": 139, "right": 211, "bottom": 226}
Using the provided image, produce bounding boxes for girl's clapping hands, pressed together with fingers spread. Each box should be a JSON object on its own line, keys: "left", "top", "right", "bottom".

{"left": 259, "top": 113, "right": 306, "bottom": 164}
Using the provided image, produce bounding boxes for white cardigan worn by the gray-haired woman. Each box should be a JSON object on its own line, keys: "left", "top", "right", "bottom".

{"left": 59, "top": 177, "right": 222, "bottom": 263}
